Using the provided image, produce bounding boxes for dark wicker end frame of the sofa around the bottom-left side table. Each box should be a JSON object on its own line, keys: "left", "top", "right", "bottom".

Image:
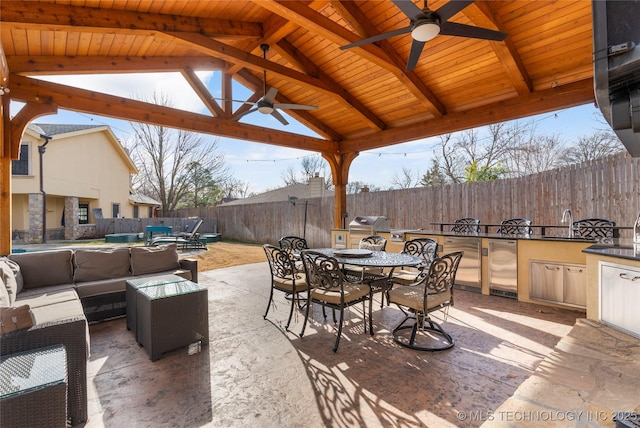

{"left": 0, "top": 317, "right": 89, "bottom": 425}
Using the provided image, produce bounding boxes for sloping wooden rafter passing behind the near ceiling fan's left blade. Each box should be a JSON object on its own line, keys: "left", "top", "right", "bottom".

{"left": 331, "top": 0, "right": 447, "bottom": 117}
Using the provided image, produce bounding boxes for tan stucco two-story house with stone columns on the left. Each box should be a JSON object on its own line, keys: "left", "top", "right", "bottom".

{"left": 11, "top": 124, "right": 159, "bottom": 243}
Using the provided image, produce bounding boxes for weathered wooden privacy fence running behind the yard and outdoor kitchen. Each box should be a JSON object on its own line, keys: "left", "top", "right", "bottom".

{"left": 176, "top": 153, "right": 640, "bottom": 247}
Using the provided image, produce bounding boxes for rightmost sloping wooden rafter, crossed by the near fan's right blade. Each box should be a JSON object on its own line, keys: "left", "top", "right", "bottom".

{"left": 463, "top": 1, "right": 533, "bottom": 95}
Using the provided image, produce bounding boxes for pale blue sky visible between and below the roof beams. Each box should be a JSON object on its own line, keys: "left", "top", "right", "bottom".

{"left": 11, "top": 72, "right": 603, "bottom": 193}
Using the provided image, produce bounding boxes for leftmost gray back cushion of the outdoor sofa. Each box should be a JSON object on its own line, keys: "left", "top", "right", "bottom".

{"left": 9, "top": 250, "right": 73, "bottom": 289}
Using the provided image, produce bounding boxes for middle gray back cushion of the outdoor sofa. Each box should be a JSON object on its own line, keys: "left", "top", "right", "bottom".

{"left": 73, "top": 248, "right": 131, "bottom": 282}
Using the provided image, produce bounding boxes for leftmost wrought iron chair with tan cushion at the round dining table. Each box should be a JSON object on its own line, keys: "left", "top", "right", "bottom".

{"left": 262, "top": 244, "right": 307, "bottom": 330}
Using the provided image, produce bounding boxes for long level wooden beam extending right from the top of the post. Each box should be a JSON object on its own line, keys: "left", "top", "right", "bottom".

{"left": 340, "top": 79, "right": 595, "bottom": 153}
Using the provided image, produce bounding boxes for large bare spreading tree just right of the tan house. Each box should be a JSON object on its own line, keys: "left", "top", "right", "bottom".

{"left": 131, "top": 93, "right": 229, "bottom": 215}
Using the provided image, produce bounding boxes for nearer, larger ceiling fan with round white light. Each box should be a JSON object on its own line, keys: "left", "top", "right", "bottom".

{"left": 340, "top": 0, "right": 507, "bottom": 71}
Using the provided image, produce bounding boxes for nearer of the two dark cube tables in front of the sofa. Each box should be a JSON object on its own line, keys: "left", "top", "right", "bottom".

{"left": 136, "top": 280, "right": 209, "bottom": 361}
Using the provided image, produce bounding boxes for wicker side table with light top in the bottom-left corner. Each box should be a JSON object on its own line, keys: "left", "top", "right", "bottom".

{"left": 0, "top": 345, "right": 67, "bottom": 428}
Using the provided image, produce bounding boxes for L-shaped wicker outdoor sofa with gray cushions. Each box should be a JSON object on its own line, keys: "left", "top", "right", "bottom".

{"left": 0, "top": 244, "right": 198, "bottom": 425}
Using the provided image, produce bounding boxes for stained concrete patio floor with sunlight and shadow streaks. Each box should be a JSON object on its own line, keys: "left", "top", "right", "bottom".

{"left": 86, "top": 263, "right": 640, "bottom": 427}
